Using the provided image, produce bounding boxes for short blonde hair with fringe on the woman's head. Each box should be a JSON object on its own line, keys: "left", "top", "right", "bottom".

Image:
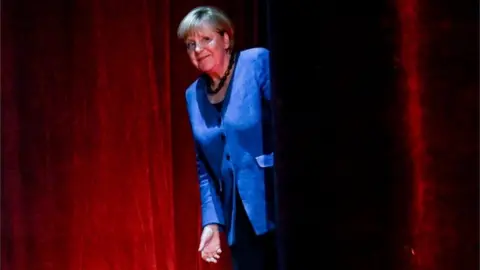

{"left": 177, "top": 6, "right": 234, "bottom": 49}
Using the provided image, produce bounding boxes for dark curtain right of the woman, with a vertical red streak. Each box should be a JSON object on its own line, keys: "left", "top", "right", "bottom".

{"left": 268, "top": 0, "right": 479, "bottom": 270}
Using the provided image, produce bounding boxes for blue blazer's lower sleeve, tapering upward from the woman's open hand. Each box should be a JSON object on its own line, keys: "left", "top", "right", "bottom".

{"left": 195, "top": 143, "right": 225, "bottom": 227}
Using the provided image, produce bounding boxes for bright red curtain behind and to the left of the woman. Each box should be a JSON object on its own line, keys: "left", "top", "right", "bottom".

{"left": 1, "top": 0, "right": 257, "bottom": 270}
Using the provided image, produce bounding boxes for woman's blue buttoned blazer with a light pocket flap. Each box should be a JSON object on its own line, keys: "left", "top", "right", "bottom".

{"left": 186, "top": 48, "right": 274, "bottom": 245}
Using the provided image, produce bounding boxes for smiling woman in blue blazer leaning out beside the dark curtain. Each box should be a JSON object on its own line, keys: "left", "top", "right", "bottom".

{"left": 178, "top": 7, "right": 276, "bottom": 270}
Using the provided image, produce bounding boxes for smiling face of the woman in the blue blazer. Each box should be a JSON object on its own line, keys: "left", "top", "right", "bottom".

{"left": 185, "top": 24, "right": 230, "bottom": 73}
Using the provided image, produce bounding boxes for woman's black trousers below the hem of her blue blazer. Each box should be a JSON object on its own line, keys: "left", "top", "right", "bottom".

{"left": 230, "top": 191, "right": 278, "bottom": 270}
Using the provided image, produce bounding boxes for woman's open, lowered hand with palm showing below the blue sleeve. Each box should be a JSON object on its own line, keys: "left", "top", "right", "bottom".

{"left": 198, "top": 224, "right": 222, "bottom": 263}
